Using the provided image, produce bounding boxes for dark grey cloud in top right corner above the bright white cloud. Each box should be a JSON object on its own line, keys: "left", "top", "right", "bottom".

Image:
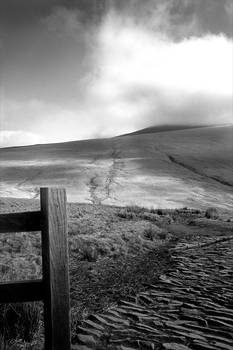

{"left": 111, "top": 0, "right": 233, "bottom": 40}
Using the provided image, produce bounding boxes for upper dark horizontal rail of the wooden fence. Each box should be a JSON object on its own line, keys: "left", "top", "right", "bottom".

{"left": 0, "top": 211, "right": 41, "bottom": 233}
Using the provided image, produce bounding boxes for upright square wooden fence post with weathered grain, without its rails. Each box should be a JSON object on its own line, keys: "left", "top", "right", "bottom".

{"left": 40, "top": 188, "right": 71, "bottom": 350}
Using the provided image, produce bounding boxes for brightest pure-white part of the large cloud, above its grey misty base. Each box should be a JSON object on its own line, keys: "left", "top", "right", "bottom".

{"left": 96, "top": 16, "right": 232, "bottom": 96}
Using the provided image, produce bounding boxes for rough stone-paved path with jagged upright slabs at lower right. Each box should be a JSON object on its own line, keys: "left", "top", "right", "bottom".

{"left": 74, "top": 237, "right": 233, "bottom": 350}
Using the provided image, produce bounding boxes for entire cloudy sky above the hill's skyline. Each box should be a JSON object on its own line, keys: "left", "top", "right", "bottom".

{"left": 0, "top": 0, "right": 233, "bottom": 147}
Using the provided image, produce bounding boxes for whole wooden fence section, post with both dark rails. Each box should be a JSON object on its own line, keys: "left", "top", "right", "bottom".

{"left": 0, "top": 188, "right": 71, "bottom": 350}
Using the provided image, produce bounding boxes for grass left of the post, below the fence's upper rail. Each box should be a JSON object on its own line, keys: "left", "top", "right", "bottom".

{"left": 0, "top": 226, "right": 43, "bottom": 350}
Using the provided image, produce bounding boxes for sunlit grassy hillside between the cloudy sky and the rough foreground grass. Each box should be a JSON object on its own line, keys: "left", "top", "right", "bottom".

{"left": 0, "top": 126, "right": 233, "bottom": 210}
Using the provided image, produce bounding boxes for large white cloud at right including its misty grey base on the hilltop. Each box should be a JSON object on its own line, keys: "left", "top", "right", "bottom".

{"left": 81, "top": 12, "right": 232, "bottom": 134}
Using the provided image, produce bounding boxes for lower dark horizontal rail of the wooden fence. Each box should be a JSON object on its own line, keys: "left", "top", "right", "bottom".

{"left": 0, "top": 280, "right": 44, "bottom": 303}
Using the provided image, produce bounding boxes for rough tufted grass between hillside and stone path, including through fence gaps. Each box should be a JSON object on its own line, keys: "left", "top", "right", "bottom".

{"left": 0, "top": 200, "right": 233, "bottom": 350}
